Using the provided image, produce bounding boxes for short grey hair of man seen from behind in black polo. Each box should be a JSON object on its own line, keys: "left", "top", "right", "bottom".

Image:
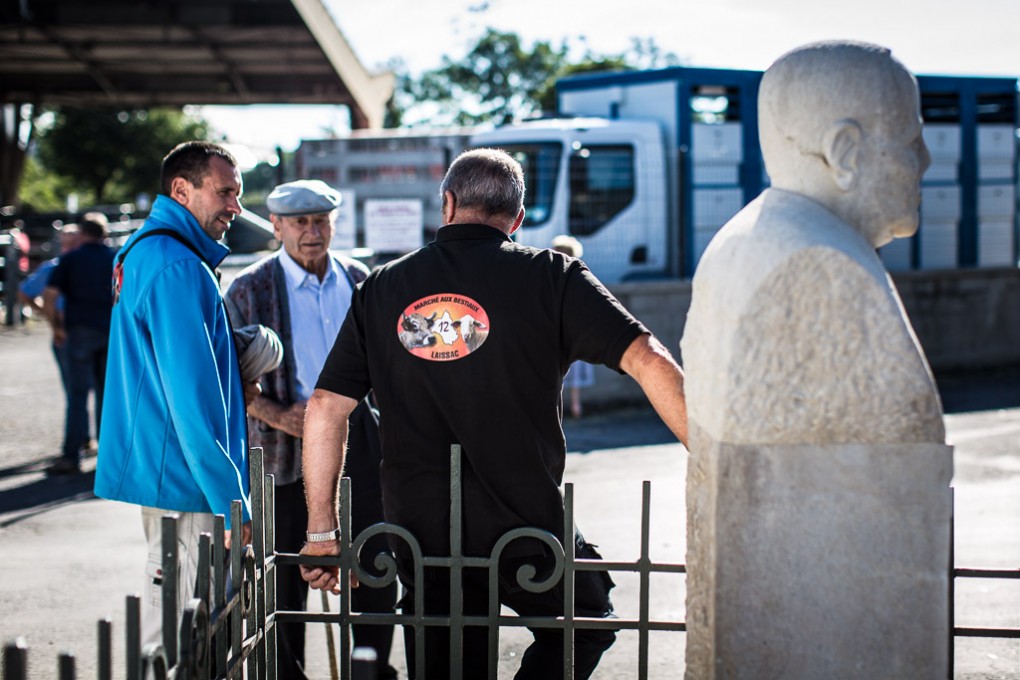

{"left": 440, "top": 149, "right": 524, "bottom": 219}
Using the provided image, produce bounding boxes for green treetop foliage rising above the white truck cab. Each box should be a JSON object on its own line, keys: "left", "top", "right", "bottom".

{"left": 387, "top": 28, "right": 679, "bottom": 126}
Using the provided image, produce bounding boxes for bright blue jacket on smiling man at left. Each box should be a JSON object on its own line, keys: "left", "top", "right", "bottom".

{"left": 95, "top": 196, "right": 251, "bottom": 528}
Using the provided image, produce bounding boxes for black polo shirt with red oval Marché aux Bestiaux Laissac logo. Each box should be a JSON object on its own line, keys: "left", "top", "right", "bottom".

{"left": 317, "top": 224, "right": 647, "bottom": 559}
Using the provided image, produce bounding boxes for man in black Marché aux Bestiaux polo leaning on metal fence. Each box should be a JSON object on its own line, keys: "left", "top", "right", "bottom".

{"left": 302, "top": 149, "right": 686, "bottom": 679}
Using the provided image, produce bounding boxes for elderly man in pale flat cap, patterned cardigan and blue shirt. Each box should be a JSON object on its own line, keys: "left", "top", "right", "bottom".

{"left": 226, "top": 179, "right": 397, "bottom": 680}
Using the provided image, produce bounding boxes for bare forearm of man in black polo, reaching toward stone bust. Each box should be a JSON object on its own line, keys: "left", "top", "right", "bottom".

{"left": 620, "top": 333, "right": 687, "bottom": 447}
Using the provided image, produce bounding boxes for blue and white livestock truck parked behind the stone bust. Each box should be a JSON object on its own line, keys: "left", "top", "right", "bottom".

{"left": 471, "top": 67, "right": 1018, "bottom": 283}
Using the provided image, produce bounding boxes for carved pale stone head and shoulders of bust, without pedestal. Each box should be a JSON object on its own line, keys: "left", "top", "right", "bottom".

{"left": 681, "top": 42, "right": 945, "bottom": 450}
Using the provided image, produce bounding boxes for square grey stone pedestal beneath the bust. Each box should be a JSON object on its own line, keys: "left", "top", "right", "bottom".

{"left": 686, "top": 434, "right": 953, "bottom": 680}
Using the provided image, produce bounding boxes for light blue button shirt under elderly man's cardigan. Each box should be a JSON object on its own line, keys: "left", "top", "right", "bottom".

{"left": 279, "top": 251, "right": 354, "bottom": 400}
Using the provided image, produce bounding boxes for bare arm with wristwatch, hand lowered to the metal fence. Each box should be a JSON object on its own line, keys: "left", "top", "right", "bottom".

{"left": 301, "top": 389, "right": 358, "bottom": 592}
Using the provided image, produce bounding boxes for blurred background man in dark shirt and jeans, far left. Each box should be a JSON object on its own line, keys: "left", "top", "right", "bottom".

{"left": 43, "top": 213, "right": 113, "bottom": 474}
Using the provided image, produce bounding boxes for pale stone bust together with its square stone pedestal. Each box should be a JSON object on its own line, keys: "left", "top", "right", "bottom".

{"left": 680, "top": 42, "right": 953, "bottom": 680}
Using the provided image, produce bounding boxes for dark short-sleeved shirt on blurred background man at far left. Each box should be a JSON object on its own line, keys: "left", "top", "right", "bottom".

{"left": 47, "top": 242, "right": 114, "bottom": 332}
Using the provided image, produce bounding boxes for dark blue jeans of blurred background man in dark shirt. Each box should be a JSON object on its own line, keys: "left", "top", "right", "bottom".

{"left": 63, "top": 326, "right": 109, "bottom": 463}
